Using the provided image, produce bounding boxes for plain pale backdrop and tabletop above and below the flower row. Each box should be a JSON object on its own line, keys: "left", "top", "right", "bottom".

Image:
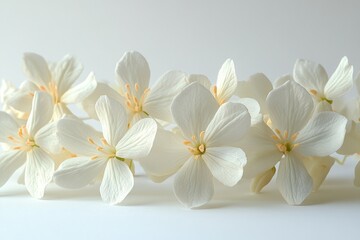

{"left": 0, "top": 0, "right": 360, "bottom": 239}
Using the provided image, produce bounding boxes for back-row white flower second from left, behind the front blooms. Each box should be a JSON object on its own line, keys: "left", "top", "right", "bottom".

{"left": 83, "top": 52, "right": 187, "bottom": 125}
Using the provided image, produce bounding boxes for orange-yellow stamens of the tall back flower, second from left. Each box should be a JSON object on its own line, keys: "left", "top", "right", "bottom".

{"left": 125, "top": 83, "right": 150, "bottom": 115}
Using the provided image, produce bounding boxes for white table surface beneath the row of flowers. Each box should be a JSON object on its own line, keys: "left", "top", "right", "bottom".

{"left": 0, "top": 160, "right": 360, "bottom": 240}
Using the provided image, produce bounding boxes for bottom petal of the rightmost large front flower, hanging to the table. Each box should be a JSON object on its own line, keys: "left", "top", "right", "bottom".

{"left": 277, "top": 154, "right": 313, "bottom": 205}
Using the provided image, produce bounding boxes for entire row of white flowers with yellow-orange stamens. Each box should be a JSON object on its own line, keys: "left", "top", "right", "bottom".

{"left": 0, "top": 52, "right": 360, "bottom": 208}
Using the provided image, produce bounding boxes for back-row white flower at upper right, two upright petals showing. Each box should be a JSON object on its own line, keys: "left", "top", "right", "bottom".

{"left": 294, "top": 57, "right": 353, "bottom": 112}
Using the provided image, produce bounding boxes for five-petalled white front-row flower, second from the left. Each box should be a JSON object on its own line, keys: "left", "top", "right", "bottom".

{"left": 54, "top": 96, "right": 157, "bottom": 204}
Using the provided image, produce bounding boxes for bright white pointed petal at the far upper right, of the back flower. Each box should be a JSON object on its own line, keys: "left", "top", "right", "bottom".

{"left": 324, "top": 57, "right": 353, "bottom": 99}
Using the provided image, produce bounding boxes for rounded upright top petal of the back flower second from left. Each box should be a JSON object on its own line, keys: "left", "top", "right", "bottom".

{"left": 115, "top": 52, "right": 150, "bottom": 93}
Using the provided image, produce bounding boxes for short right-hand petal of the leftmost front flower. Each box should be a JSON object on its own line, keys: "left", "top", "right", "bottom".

{"left": 34, "top": 122, "right": 62, "bottom": 153}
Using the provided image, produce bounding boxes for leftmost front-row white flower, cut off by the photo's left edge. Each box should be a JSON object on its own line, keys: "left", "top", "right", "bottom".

{"left": 0, "top": 92, "right": 59, "bottom": 198}
